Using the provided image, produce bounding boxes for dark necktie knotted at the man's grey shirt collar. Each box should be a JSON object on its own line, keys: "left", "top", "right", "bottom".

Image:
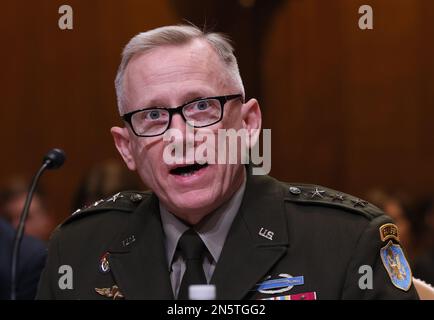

{"left": 178, "top": 229, "right": 207, "bottom": 300}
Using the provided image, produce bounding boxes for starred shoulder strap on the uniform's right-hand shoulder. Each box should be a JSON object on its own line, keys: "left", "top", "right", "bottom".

{"left": 285, "top": 184, "right": 383, "bottom": 220}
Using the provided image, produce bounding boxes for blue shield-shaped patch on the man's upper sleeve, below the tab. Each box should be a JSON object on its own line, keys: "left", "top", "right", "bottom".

{"left": 380, "top": 240, "right": 412, "bottom": 291}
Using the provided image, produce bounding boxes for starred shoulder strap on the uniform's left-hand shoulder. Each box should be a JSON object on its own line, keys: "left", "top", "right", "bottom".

{"left": 61, "top": 191, "right": 152, "bottom": 226}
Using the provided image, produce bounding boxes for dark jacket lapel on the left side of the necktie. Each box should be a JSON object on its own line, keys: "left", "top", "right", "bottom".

{"left": 109, "top": 195, "right": 173, "bottom": 300}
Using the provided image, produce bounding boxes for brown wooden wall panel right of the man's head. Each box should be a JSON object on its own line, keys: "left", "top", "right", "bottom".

{"left": 263, "top": 0, "right": 434, "bottom": 194}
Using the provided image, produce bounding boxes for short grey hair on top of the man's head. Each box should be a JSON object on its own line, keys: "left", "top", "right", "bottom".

{"left": 115, "top": 25, "right": 244, "bottom": 115}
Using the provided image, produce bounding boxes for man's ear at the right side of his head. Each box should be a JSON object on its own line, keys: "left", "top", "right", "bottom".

{"left": 241, "top": 99, "right": 262, "bottom": 148}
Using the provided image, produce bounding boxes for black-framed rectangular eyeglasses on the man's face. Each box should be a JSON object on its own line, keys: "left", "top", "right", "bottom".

{"left": 122, "top": 94, "right": 242, "bottom": 137}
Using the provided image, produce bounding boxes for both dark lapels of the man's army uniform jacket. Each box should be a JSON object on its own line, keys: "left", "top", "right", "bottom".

{"left": 107, "top": 174, "right": 289, "bottom": 299}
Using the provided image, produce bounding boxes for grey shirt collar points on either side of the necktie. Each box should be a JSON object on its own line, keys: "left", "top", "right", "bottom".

{"left": 160, "top": 170, "right": 246, "bottom": 270}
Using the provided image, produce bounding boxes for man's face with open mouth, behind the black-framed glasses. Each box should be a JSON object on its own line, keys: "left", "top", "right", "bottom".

{"left": 112, "top": 40, "right": 261, "bottom": 224}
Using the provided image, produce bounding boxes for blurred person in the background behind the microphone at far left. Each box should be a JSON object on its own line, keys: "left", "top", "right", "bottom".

{"left": 0, "top": 177, "right": 47, "bottom": 300}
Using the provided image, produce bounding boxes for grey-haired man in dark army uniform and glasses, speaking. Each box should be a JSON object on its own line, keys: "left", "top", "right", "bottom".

{"left": 38, "top": 26, "right": 418, "bottom": 300}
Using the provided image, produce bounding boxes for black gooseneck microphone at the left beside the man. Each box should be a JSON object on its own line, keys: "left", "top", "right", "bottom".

{"left": 11, "top": 149, "right": 65, "bottom": 300}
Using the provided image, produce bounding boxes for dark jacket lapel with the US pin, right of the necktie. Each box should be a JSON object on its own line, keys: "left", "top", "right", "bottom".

{"left": 211, "top": 175, "right": 288, "bottom": 300}
